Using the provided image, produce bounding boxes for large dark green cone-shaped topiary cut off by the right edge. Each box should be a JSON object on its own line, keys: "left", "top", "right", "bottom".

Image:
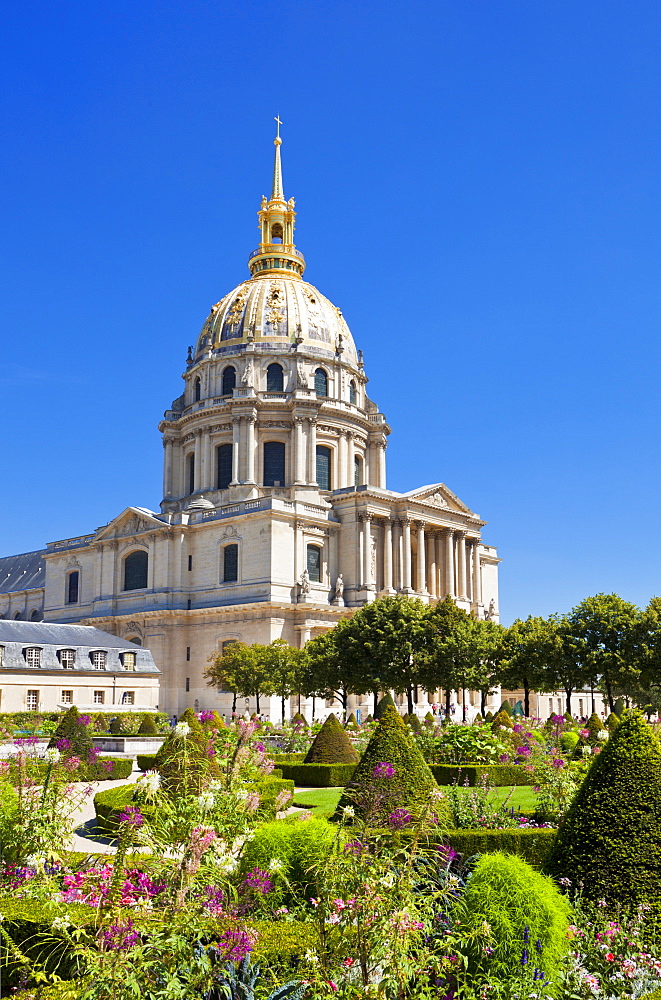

{"left": 547, "top": 713, "right": 661, "bottom": 919}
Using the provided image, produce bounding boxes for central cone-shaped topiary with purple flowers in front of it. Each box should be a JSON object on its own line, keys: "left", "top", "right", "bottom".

{"left": 335, "top": 705, "right": 443, "bottom": 825}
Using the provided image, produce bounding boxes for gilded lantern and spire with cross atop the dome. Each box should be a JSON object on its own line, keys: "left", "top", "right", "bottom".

{"left": 248, "top": 118, "right": 305, "bottom": 278}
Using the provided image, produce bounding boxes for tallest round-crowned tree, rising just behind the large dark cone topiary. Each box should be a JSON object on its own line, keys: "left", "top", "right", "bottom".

{"left": 565, "top": 594, "right": 644, "bottom": 712}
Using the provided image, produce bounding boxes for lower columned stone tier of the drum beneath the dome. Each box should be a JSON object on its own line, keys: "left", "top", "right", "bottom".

{"left": 163, "top": 411, "right": 386, "bottom": 497}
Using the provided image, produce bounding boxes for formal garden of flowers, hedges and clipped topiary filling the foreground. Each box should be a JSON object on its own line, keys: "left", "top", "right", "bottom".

{"left": 0, "top": 588, "right": 661, "bottom": 1000}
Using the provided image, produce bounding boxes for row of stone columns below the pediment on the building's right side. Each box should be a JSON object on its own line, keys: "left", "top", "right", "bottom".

{"left": 357, "top": 513, "right": 482, "bottom": 604}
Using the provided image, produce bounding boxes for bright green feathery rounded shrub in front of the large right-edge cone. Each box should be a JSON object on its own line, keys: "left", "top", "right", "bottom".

{"left": 455, "top": 852, "right": 571, "bottom": 981}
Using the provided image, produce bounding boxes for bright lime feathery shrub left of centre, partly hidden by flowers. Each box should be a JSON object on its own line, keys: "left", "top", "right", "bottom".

{"left": 239, "top": 818, "right": 337, "bottom": 905}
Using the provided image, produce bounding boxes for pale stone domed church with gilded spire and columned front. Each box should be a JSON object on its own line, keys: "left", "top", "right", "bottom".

{"left": 0, "top": 134, "right": 500, "bottom": 720}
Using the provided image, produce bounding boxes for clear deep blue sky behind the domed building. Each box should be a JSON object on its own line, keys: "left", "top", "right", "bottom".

{"left": 0, "top": 0, "right": 661, "bottom": 622}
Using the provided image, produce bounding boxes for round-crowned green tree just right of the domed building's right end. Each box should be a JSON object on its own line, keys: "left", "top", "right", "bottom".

{"left": 497, "top": 615, "right": 553, "bottom": 718}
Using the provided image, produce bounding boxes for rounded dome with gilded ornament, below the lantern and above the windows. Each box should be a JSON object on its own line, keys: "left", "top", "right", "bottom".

{"left": 195, "top": 275, "right": 357, "bottom": 365}
